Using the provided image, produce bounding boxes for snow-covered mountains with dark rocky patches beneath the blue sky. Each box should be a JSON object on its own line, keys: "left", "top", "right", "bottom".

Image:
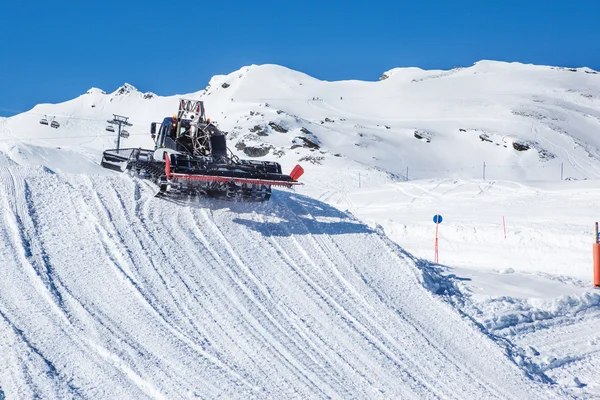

{"left": 0, "top": 61, "right": 600, "bottom": 182}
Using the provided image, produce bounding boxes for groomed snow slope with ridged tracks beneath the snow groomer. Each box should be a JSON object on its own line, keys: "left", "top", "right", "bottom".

{"left": 0, "top": 166, "right": 559, "bottom": 399}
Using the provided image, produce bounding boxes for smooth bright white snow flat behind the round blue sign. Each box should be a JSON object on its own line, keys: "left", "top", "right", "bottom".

{"left": 332, "top": 179, "right": 600, "bottom": 283}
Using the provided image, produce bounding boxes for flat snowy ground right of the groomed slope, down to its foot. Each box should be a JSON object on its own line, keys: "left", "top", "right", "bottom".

{"left": 324, "top": 179, "right": 600, "bottom": 397}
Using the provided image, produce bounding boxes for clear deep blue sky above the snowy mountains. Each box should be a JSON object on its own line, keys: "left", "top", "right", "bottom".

{"left": 0, "top": 0, "right": 600, "bottom": 116}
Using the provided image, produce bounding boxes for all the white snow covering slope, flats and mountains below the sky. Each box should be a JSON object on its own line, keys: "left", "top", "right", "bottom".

{"left": 0, "top": 61, "right": 600, "bottom": 398}
